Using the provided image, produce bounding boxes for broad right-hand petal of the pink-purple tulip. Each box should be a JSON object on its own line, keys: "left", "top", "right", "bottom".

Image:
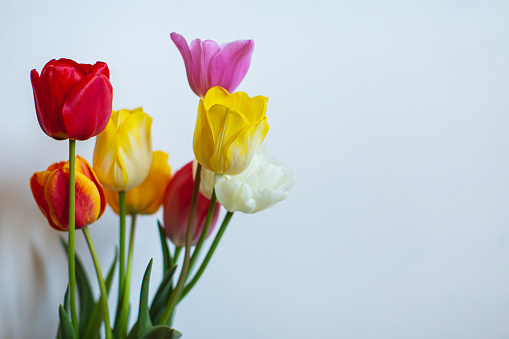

{"left": 210, "top": 40, "right": 254, "bottom": 93}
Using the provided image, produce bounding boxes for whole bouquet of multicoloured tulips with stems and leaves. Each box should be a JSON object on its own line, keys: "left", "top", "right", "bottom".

{"left": 30, "top": 33, "right": 294, "bottom": 339}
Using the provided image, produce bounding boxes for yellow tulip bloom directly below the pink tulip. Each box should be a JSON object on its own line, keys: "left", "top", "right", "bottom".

{"left": 193, "top": 87, "right": 269, "bottom": 175}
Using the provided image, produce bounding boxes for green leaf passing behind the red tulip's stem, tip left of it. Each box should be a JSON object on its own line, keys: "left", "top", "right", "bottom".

{"left": 60, "top": 238, "right": 95, "bottom": 336}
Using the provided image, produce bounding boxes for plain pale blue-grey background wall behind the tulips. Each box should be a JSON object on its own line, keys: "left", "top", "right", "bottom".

{"left": 0, "top": 0, "right": 509, "bottom": 339}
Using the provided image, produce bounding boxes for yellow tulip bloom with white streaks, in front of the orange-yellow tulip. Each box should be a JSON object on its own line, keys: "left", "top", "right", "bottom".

{"left": 94, "top": 107, "right": 153, "bottom": 192}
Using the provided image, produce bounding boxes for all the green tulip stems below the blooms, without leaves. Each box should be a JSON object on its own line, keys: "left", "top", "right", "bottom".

{"left": 64, "top": 139, "right": 233, "bottom": 339}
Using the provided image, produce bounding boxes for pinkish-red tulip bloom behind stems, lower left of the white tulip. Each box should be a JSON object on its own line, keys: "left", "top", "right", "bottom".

{"left": 164, "top": 161, "right": 219, "bottom": 247}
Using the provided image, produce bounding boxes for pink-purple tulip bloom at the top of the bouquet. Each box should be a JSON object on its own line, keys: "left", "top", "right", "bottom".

{"left": 170, "top": 32, "right": 254, "bottom": 97}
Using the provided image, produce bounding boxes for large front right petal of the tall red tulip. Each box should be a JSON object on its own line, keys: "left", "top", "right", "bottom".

{"left": 62, "top": 74, "right": 113, "bottom": 140}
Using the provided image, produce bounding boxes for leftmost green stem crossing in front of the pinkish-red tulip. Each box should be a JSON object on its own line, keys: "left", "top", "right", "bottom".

{"left": 158, "top": 163, "right": 201, "bottom": 325}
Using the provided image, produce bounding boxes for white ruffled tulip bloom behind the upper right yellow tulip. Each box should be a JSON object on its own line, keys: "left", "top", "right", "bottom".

{"left": 200, "top": 148, "right": 295, "bottom": 213}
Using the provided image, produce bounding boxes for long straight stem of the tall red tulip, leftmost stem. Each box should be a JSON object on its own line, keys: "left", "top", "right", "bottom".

{"left": 68, "top": 139, "right": 79, "bottom": 338}
